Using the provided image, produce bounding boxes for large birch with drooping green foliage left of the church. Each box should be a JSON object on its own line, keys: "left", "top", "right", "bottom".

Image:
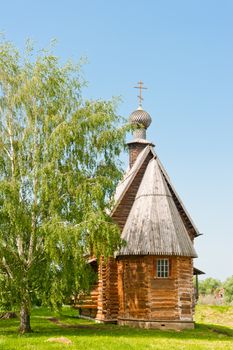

{"left": 0, "top": 41, "right": 126, "bottom": 332}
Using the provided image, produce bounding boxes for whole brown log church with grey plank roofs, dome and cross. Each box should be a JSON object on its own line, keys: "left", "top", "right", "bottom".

{"left": 77, "top": 82, "right": 202, "bottom": 330}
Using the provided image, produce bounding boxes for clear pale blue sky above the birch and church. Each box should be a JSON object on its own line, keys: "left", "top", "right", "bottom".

{"left": 0, "top": 0, "right": 233, "bottom": 280}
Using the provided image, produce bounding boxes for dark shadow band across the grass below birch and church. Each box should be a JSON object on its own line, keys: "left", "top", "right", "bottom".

{"left": 0, "top": 315, "right": 233, "bottom": 342}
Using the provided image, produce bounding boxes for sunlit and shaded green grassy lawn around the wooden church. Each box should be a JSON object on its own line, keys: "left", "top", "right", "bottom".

{"left": 0, "top": 306, "right": 233, "bottom": 350}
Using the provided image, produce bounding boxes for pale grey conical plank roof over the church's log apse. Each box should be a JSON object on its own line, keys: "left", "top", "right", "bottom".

{"left": 117, "top": 157, "right": 197, "bottom": 257}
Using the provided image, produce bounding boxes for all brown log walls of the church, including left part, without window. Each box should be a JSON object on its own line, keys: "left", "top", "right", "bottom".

{"left": 77, "top": 256, "right": 194, "bottom": 329}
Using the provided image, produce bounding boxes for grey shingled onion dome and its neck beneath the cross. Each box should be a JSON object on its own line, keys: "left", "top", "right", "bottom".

{"left": 129, "top": 106, "right": 152, "bottom": 139}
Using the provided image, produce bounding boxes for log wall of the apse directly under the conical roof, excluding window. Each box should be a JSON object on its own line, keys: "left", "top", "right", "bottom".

{"left": 118, "top": 256, "right": 193, "bottom": 329}
